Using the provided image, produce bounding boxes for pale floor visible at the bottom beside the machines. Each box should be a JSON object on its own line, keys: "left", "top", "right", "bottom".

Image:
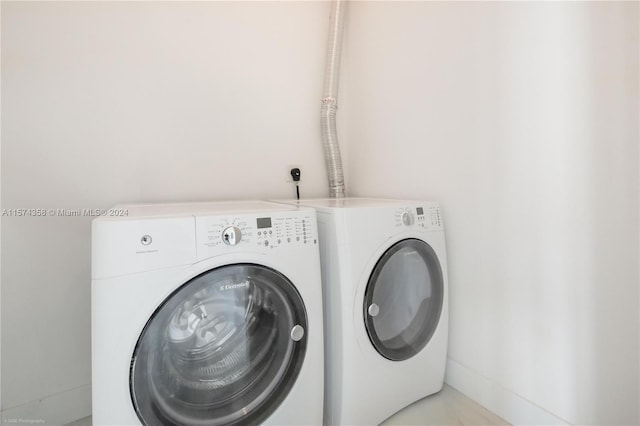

{"left": 66, "top": 385, "right": 509, "bottom": 426}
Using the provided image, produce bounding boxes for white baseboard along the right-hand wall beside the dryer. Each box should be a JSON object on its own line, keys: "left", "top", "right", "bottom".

{"left": 444, "top": 358, "right": 569, "bottom": 425}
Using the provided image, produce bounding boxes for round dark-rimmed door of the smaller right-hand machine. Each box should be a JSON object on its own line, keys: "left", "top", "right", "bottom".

{"left": 364, "top": 239, "right": 444, "bottom": 361}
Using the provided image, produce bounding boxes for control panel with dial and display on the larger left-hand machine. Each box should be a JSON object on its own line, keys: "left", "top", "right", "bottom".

{"left": 196, "top": 211, "right": 318, "bottom": 257}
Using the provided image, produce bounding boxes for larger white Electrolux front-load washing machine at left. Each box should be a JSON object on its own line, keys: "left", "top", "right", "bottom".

{"left": 92, "top": 201, "right": 323, "bottom": 426}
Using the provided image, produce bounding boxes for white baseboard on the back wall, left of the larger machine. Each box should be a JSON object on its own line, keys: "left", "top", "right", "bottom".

{"left": 2, "top": 385, "right": 91, "bottom": 426}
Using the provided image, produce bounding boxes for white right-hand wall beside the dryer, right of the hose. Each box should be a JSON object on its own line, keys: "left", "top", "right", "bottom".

{"left": 343, "top": 2, "right": 640, "bottom": 424}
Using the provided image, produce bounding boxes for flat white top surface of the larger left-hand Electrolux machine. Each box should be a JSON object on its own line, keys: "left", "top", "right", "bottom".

{"left": 99, "top": 201, "right": 308, "bottom": 220}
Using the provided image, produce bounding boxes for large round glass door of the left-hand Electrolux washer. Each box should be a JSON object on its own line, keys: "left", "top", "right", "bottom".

{"left": 130, "top": 264, "right": 307, "bottom": 426}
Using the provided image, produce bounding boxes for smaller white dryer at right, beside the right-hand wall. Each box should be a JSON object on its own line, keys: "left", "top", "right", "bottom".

{"left": 272, "top": 198, "right": 448, "bottom": 425}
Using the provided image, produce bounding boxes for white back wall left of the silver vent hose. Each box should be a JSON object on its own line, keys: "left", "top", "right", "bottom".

{"left": 1, "top": 1, "right": 336, "bottom": 424}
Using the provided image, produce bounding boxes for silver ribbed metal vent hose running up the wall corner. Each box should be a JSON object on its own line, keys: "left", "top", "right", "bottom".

{"left": 320, "top": 0, "right": 346, "bottom": 198}
